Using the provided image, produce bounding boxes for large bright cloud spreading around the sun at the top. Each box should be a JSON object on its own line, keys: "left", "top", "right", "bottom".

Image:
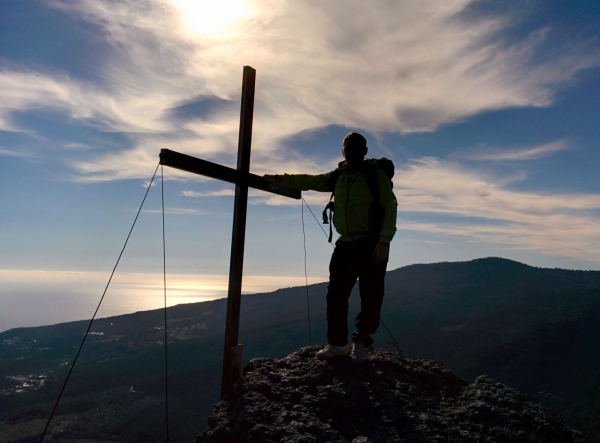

{"left": 0, "top": 0, "right": 600, "bottom": 181}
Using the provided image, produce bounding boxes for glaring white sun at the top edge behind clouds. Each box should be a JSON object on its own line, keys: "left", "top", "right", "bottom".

{"left": 174, "top": 0, "right": 252, "bottom": 37}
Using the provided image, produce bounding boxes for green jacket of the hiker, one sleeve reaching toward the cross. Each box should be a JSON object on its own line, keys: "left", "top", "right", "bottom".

{"left": 280, "top": 159, "right": 397, "bottom": 244}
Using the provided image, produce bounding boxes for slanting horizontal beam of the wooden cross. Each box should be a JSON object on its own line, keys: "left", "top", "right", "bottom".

{"left": 160, "top": 149, "right": 302, "bottom": 200}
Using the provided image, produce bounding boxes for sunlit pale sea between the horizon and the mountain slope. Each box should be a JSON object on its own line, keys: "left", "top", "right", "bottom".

{"left": 0, "top": 270, "right": 324, "bottom": 332}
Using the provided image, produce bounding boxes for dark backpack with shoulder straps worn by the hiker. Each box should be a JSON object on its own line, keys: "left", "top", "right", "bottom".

{"left": 323, "top": 157, "right": 398, "bottom": 243}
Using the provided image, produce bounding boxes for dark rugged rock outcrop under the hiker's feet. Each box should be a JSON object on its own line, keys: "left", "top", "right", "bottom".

{"left": 197, "top": 346, "right": 586, "bottom": 443}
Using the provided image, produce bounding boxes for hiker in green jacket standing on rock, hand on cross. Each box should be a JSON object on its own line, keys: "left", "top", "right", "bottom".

{"left": 264, "top": 132, "right": 397, "bottom": 363}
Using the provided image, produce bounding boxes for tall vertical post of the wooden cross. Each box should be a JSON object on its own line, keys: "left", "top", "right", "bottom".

{"left": 221, "top": 66, "right": 256, "bottom": 398}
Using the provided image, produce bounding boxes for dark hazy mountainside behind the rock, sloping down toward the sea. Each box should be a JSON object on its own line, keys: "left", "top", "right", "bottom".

{"left": 0, "top": 258, "right": 600, "bottom": 442}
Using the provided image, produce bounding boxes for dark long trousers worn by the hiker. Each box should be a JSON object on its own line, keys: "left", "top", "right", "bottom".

{"left": 327, "top": 237, "right": 387, "bottom": 347}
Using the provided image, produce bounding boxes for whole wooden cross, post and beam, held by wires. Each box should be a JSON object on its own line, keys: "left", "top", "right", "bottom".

{"left": 160, "top": 66, "right": 301, "bottom": 398}
